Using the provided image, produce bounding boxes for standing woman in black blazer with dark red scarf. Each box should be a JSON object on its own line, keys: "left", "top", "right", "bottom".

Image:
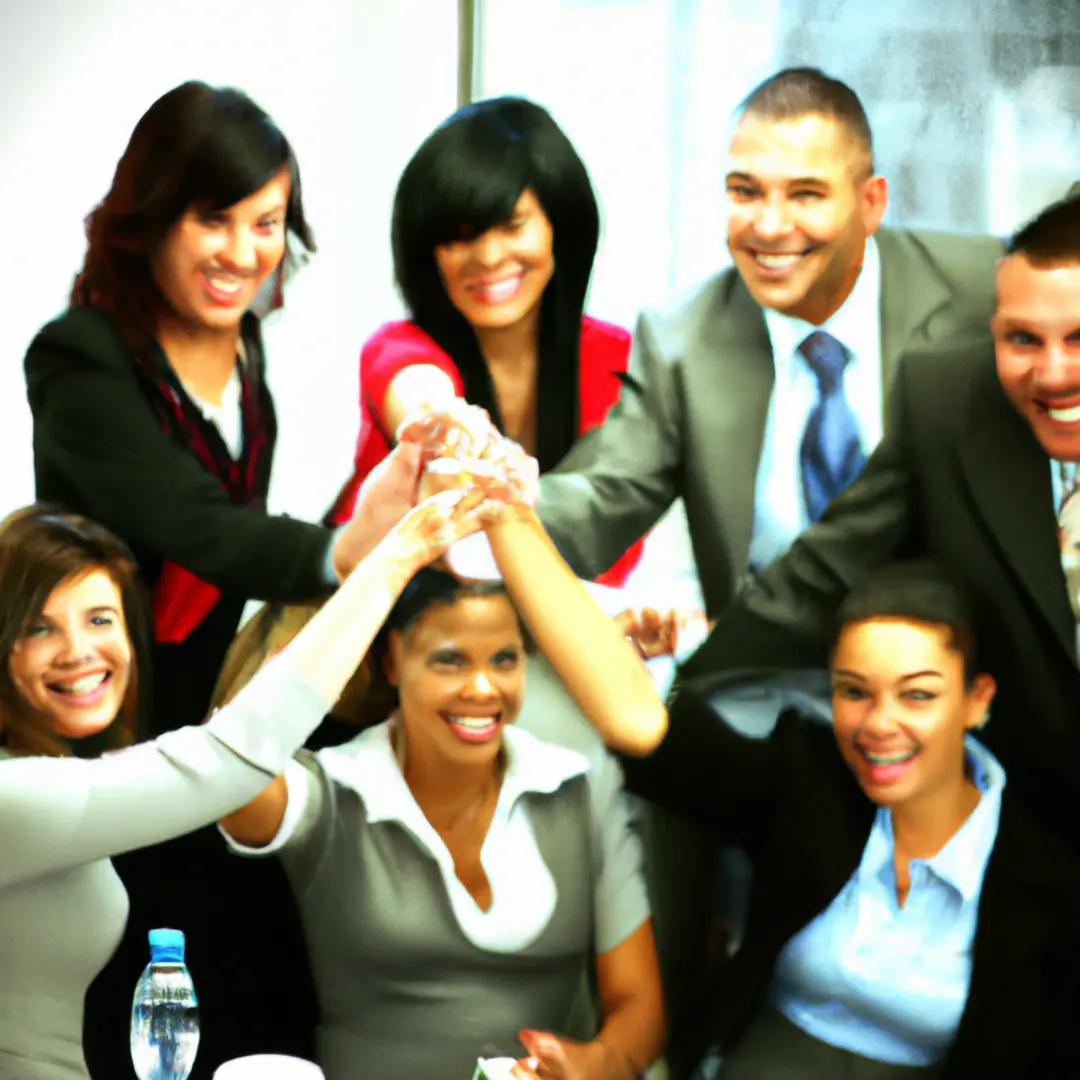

{"left": 26, "top": 82, "right": 416, "bottom": 1080}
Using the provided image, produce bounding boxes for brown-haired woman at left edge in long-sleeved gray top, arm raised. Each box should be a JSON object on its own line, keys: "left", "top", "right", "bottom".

{"left": 0, "top": 475, "right": 503, "bottom": 1080}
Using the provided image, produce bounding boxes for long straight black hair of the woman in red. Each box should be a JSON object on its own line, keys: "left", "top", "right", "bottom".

{"left": 391, "top": 97, "right": 599, "bottom": 471}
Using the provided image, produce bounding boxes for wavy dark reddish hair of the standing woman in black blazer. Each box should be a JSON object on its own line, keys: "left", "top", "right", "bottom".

{"left": 71, "top": 82, "right": 315, "bottom": 357}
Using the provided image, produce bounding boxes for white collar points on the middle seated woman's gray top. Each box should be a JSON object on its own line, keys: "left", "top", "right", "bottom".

{"left": 318, "top": 720, "right": 589, "bottom": 832}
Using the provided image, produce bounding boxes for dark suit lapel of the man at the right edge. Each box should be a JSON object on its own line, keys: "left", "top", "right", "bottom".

{"left": 960, "top": 357, "right": 1077, "bottom": 663}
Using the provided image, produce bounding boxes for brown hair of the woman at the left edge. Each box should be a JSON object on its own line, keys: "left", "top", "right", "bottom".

{"left": 0, "top": 505, "right": 149, "bottom": 756}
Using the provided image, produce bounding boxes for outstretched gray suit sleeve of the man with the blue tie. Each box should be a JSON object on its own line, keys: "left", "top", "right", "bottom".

{"left": 537, "top": 315, "right": 683, "bottom": 579}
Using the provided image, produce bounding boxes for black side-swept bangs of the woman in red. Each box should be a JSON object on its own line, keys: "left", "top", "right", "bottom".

{"left": 417, "top": 121, "right": 531, "bottom": 248}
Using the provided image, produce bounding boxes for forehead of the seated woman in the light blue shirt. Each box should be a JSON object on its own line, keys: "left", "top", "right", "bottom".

{"left": 833, "top": 619, "right": 961, "bottom": 676}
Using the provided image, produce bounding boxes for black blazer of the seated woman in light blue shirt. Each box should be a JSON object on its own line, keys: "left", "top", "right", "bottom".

{"left": 622, "top": 689, "right": 1080, "bottom": 1080}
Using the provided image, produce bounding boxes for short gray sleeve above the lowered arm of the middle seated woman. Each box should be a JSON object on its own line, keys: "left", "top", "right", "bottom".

{"left": 586, "top": 753, "right": 650, "bottom": 955}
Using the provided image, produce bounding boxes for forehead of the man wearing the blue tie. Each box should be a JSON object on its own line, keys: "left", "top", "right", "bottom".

{"left": 728, "top": 113, "right": 853, "bottom": 183}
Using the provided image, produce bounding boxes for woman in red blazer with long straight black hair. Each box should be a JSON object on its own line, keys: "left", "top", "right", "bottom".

{"left": 327, "top": 97, "right": 642, "bottom": 585}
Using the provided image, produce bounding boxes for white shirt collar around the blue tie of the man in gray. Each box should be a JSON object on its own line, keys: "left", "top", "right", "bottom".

{"left": 762, "top": 237, "right": 881, "bottom": 382}
